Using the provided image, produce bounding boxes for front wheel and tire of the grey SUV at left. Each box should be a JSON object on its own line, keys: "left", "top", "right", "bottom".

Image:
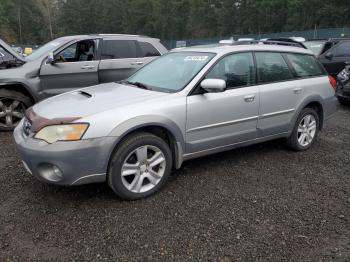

{"left": 0, "top": 89, "right": 33, "bottom": 131}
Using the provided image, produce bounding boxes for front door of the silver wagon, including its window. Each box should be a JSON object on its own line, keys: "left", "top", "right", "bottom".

{"left": 186, "top": 52, "right": 259, "bottom": 153}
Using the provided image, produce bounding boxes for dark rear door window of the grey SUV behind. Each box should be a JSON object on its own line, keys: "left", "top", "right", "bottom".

{"left": 101, "top": 40, "right": 136, "bottom": 60}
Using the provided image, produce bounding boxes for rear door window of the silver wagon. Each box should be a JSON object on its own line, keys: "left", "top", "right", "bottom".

{"left": 255, "top": 52, "right": 293, "bottom": 83}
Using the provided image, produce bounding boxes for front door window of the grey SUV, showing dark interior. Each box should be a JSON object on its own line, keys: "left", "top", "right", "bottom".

{"left": 56, "top": 40, "right": 95, "bottom": 63}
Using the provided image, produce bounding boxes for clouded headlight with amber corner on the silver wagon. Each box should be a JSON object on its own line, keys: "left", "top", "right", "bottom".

{"left": 34, "top": 124, "right": 89, "bottom": 144}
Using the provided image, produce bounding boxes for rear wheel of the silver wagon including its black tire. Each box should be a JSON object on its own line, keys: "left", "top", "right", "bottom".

{"left": 287, "top": 108, "right": 320, "bottom": 151}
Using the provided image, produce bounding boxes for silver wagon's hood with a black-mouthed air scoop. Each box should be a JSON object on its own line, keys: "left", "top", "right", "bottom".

{"left": 33, "top": 83, "right": 169, "bottom": 119}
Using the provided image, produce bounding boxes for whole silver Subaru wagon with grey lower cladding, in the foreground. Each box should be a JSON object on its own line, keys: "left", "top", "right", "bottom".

{"left": 14, "top": 43, "right": 336, "bottom": 200}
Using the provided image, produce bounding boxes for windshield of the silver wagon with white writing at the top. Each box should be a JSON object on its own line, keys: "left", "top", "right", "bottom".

{"left": 128, "top": 52, "right": 215, "bottom": 92}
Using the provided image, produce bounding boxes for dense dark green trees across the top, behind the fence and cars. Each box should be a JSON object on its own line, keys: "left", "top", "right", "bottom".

{"left": 0, "top": 0, "right": 350, "bottom": 43}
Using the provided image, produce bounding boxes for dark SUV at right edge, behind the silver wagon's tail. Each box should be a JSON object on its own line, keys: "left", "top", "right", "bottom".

{"left": 318, "top": 38, "right": 350, "bottom": 77}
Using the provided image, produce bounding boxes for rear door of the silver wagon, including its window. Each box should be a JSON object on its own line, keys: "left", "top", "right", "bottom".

{"left": 255, "top": 52, "right": 303, "bottom": 137}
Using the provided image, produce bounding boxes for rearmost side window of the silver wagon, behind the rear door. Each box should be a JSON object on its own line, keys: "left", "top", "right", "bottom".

{"left": 287, "top": 54, "right": 323, "bottom": 77}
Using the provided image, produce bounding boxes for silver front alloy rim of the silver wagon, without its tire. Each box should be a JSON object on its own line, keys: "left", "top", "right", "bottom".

{"left": 121, "top": 145, "right": 166, "bottom": 193}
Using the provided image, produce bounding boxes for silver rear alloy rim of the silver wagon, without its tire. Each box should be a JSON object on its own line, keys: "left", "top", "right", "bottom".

{"left": 298, "top": 114, "right": 317, "bottom": 147}
